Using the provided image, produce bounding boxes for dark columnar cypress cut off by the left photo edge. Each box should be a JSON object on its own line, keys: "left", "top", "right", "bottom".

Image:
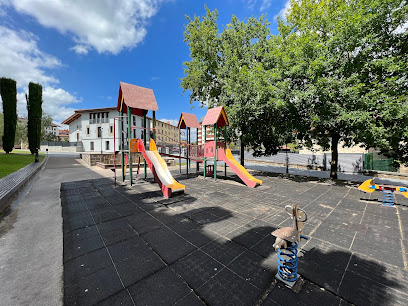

{"left": 0, "top": 78, "right": 17, "bottom": 153}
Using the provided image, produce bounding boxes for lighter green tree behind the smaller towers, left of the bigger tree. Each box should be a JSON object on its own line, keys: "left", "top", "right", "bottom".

{"left": 181, "top": 7, "right": 293, "bottom": 165}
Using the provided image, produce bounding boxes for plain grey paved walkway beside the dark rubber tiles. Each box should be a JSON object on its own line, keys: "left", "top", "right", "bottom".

{"left": 0, "top": 156, "right": 101, "bottom": 306}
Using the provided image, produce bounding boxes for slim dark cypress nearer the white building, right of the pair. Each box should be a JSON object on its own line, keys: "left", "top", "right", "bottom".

{"left": 27, "top": 82, "right": 42, "bottom": 154}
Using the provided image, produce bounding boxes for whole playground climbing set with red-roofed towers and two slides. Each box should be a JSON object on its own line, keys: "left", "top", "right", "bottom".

{"left": 114, "top": 82, "right": 262, "bottom": 198}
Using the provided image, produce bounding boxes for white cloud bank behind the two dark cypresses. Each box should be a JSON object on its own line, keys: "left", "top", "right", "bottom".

{"left": 0, "top": 26, "right": 80, "bottom": 122}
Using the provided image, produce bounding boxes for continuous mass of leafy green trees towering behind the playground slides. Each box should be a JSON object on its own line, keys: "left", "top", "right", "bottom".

{"left": 181, "top": 0, "right": 408, "bottom": 179}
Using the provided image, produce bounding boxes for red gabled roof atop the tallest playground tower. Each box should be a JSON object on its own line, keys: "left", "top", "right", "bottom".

{"left": 117, "top": 82, "right": 159, "bottom": 116}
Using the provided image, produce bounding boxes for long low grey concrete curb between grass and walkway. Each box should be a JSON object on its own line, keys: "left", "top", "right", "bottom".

{"left": 0, "top": 156, "right": 48, "bottom": 214}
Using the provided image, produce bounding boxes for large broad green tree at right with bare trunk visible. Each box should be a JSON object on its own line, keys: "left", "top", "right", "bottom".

{"left": 279, "top": 0, "right": 407, "bottom": 179}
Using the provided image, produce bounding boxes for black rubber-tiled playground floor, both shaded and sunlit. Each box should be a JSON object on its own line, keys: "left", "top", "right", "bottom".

{"left": 61, "top": 171, "right": 408, "bottom": 305}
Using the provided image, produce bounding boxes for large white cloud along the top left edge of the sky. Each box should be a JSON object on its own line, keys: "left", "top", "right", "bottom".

{"left": 0, "top": 0, "right": 167, "bottom": 54}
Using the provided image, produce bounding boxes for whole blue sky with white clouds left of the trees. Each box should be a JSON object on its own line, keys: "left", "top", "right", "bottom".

{"left": 0, "top": 0, "right": 288, "bottom": 123}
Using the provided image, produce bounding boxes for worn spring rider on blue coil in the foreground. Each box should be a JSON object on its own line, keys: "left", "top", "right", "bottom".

{"left": 272, "top": 204, "right": 309, "bottom": 288}
